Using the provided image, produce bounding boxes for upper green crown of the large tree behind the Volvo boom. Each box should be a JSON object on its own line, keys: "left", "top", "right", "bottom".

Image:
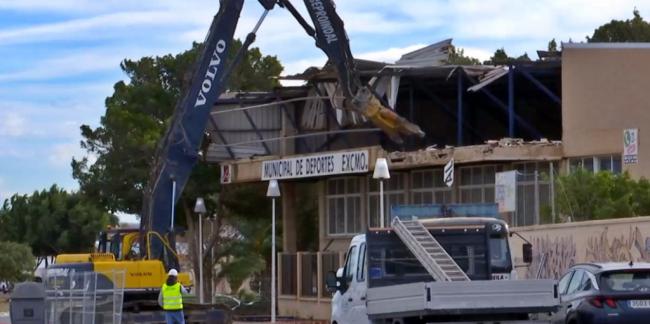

{"left": 72, "top": 40, "right": 283, "bottom": 214}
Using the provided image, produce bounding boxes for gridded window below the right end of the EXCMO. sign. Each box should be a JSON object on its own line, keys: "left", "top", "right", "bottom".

{"left": 326, "top": 177, "right": 361, "bottom": 234}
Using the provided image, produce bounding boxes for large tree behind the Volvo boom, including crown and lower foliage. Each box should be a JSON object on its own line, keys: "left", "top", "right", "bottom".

{"left": 72, "top": 41, "right": 283, "bottom": 302}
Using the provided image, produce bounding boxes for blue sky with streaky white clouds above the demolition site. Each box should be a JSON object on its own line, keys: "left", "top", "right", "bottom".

{"left": 0, "top": 0, "right": 650, "bottom": 203}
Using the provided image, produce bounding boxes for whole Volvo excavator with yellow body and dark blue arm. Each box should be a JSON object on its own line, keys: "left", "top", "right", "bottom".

{"left": 52, "top": 0, "right": 424, "bottom": 315}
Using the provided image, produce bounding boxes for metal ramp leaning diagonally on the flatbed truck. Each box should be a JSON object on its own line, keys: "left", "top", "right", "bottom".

{"left": 392, "top": 217, "right": 470, "bottom": 281}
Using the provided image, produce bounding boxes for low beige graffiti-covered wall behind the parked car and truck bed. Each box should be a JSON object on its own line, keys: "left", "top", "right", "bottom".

{"left": 510, "top": 217, "right": 650, "bottom": 279}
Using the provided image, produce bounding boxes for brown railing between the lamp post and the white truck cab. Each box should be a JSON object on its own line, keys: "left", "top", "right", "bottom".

{"left": 278, "top": 252, "right": 344, "bottom": 301}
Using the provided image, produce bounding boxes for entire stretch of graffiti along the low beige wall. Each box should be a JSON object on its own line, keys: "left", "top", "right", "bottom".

{"left": 525, "top": 225, "right": 650, "bottom": 279}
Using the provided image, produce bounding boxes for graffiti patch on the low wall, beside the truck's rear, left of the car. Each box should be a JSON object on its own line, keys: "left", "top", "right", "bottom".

{"left": 526, "top": 236, "right": 576, "bottom": 279}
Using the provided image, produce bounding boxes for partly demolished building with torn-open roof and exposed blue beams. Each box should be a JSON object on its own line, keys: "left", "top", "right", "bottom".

{"left": 202, "top": 41, "right": 650, "bottom": 318}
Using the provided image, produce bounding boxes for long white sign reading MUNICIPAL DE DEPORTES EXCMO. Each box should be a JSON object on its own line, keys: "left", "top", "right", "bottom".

{"left": 262, "top": 150, "right": 369, "bottom": 181}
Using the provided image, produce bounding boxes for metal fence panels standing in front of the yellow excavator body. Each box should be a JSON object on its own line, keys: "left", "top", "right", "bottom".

{"left": 44, "top": 269, "right": 124, "bottom": 324}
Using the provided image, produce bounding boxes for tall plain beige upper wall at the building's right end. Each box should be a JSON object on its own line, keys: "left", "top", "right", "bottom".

{"left": 562, "top": 44, "right": 650, "bottom": 178}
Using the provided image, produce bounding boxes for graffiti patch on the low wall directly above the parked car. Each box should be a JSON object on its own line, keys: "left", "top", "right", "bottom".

{"left": 585, "top": 226, "right": 650, "bottom": 262}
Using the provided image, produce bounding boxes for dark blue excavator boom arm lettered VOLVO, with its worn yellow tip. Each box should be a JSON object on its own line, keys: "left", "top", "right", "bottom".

{"left": 140, "top": 0, "right": 423, "bottom": 267}
